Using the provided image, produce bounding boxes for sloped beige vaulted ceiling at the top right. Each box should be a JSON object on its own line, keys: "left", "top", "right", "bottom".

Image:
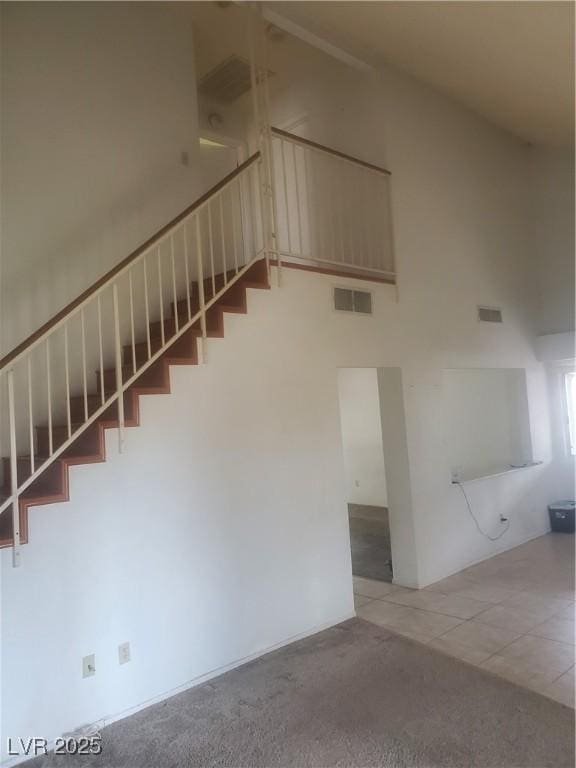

{"left": 267, "top": 0, "right": 574, "bottom": 146}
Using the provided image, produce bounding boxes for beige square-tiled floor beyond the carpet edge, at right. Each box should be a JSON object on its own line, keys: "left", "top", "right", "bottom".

{"left": 354, "top": 533, "right": 575, "bottom": 707}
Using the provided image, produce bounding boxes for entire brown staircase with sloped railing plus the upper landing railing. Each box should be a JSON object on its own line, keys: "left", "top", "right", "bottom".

{"left": 0, "top": 123, "right": 396, "bottom": 565}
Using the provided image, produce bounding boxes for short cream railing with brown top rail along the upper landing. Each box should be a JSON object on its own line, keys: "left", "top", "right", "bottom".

{"left": 271, "top": 128, "right": 396, "bottom": 282}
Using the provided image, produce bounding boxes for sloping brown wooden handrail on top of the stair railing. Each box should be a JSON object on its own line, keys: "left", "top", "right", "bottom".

{"left": 0, "top": 152, "right": 260, "bottom": 371}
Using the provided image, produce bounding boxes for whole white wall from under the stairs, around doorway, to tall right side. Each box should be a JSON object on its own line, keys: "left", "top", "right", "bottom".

{"left": 1, "top": 15, "right": 558, "bottom": 760}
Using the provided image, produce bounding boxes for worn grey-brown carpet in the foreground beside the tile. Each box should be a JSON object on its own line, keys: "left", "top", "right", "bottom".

{"left": 27, "top": 619, "right": 574, "bottom": 768}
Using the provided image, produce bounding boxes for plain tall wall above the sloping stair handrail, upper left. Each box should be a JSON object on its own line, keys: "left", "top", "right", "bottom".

{"left": 0, "top": 2, "right": 200, "bottom": 352}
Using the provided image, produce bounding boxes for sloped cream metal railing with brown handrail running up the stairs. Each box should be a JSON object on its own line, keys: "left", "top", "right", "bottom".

{"left": 0, "top": 152, "right": 269, "bottom": 565}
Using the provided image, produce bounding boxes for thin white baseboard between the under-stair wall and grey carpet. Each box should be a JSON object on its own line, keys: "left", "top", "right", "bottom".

{"left": 0, "top": 612, "right": 356, "bottom": 768}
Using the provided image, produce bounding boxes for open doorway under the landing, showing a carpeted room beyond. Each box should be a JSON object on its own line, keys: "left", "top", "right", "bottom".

{"left": 338, "top": 368, "right": 393, "bottom": 582}
